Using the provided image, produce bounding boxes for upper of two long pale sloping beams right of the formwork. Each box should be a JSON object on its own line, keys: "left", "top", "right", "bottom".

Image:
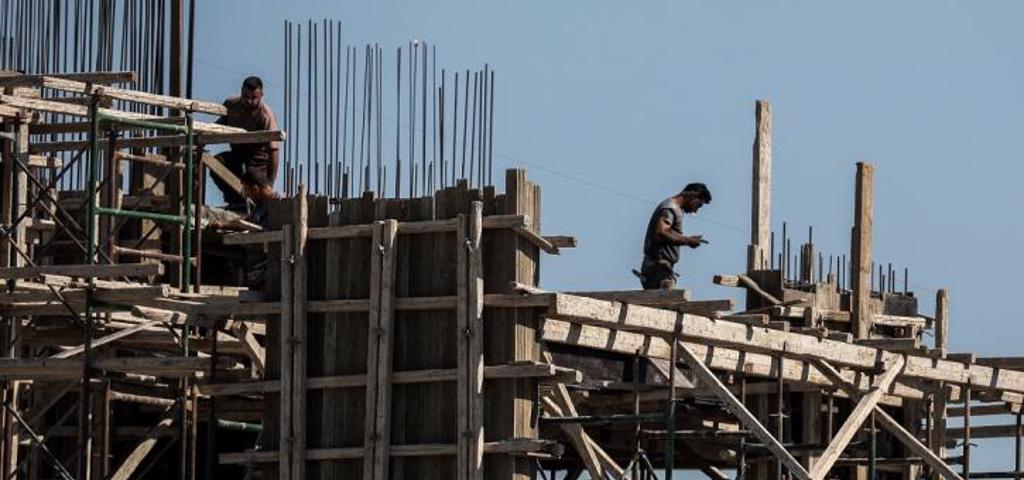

{"left": 548, "top": 294, "right": 1024, "bottom": 393}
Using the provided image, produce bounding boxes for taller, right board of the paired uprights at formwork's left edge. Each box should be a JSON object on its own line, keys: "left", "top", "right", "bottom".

{"left": 292, "top": 189, "right": 309, "bottom": 479}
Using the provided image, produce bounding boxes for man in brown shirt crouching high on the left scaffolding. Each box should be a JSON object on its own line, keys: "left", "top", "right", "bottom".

{"left": 213, "top": 77, "right": 278, "bottom": 212}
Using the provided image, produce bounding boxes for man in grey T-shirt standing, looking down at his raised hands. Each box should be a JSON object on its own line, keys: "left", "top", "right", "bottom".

{"left": 633, "top": 183, "right": 711, "bottom": 290}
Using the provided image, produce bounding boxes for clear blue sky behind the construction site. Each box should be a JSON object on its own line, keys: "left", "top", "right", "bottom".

{"left": 196, "top": 0, "right": 1024, "bottom": 470}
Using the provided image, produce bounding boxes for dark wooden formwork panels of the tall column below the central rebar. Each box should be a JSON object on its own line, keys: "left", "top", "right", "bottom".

{"left": 262, "top": 170, "right": 541, "bottom": 480}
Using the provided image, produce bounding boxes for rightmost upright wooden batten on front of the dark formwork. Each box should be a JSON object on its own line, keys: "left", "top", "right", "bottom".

{"left": 457, "top": 202, "right": 483, "bottom": 480}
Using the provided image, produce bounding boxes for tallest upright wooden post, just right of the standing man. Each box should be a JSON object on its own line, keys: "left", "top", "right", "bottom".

{"left": 746, "top": 100, "right": 772, "bottom": 271}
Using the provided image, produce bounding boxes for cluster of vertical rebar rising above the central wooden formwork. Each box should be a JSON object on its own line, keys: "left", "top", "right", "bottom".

{"left": 283, "top": 19, "right": 495, "bottom": 200}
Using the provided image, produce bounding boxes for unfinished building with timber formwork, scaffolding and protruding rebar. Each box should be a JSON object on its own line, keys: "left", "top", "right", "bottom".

{"left": 0, "top": 0, "right": 1024, "bottom": 480}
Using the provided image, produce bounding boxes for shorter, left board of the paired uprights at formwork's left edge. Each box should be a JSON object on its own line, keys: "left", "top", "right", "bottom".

{"left": 278, "top": 225, "right": 295, "bottom": 480}
